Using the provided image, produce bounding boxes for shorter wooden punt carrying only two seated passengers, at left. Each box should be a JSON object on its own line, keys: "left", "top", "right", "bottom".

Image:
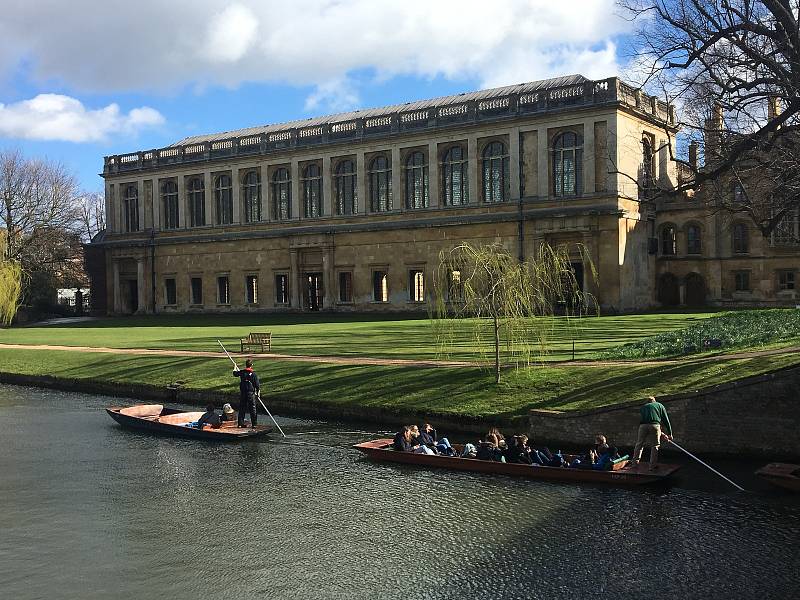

{"left": 106, "top": 404, "right": 272, "bottom": 441}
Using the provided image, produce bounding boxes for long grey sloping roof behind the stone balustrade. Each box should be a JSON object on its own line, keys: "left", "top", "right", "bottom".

{"left": 172, "top": 75, "right": 589, "bottom": 147}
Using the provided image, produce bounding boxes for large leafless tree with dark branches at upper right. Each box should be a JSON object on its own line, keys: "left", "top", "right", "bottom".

{"left": 619, "top": 0, "right": 800, "bottom": 236}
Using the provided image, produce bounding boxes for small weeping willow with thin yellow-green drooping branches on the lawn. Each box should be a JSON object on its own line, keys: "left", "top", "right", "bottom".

{"left": 431, "top": 243, "right": 597, "bottom": 383}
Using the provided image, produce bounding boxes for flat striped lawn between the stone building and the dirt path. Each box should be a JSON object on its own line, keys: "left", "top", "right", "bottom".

{"left": 0, "top": 312, "right": 714, "bottom": 360}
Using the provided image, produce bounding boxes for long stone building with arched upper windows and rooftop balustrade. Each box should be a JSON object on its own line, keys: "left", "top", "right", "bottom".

{"left": 90, "top": 75, "right": 796, "bottom": 313}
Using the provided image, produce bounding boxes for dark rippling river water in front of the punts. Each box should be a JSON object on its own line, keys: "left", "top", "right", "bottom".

{"left": 0, "top": 386, "right": 800, "bottom": 600}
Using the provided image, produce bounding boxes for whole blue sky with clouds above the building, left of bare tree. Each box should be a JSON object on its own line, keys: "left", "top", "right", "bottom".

{"left": 0, "top": 0, "right": 632, "bottom": 191}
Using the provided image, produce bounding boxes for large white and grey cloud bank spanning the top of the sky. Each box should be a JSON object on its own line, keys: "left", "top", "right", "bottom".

{"left": 0, "top": 0, "right": 630, "bottom": 107}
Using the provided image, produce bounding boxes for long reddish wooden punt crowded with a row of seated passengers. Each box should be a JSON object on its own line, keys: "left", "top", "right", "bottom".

{"left": 353, "top": 438, "right": 680, "bottom": 486}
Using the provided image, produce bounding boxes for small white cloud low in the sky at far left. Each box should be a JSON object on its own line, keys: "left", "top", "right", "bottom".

{"left": 0, "top": 94, "right": 164, "bottom": 142}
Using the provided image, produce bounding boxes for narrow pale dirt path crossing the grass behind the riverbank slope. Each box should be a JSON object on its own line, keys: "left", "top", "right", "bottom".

{"left": 0, "top": 344, "right": 800, "bottom": 368}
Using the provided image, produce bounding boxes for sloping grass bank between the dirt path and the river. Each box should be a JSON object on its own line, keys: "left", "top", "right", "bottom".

{"left": 0, "top": 350, "right": 800, "bottom": 420}
